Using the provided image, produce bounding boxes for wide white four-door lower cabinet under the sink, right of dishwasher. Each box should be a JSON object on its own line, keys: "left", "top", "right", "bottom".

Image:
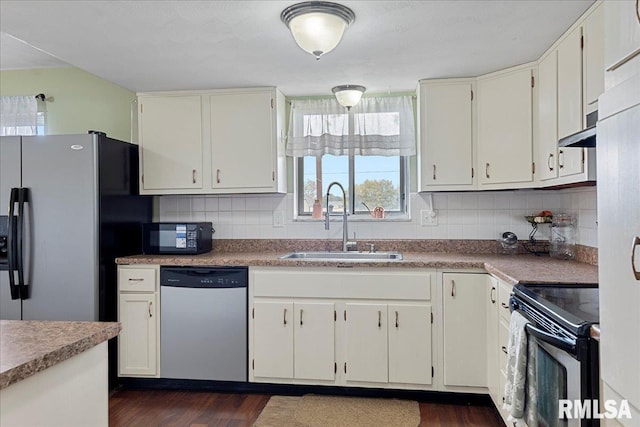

{"left": 249, "top": 267, "right": 435, "bottom": 389}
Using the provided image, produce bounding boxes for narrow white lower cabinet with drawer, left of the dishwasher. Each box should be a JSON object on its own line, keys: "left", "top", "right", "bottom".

{"left": 118, "top": 265, "right": 160, "bottom": 377}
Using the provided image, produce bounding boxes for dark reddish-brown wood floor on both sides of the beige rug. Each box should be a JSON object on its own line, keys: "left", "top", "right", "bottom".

{"left": 109, "top": 390, "right": 504, "bottom": 427}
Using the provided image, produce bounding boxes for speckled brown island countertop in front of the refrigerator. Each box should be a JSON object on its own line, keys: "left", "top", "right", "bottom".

{"left": 0, "top": 320, "right": 121, "bottom": 389}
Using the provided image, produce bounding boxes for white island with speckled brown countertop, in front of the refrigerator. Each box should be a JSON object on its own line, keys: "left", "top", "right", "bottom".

{"left": 0, "top": 320, "right": 121, "bottom": 427}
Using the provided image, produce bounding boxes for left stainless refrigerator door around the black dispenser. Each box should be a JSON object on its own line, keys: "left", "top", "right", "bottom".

{"left": 0, "top": 136, "right": 21, "bottom": 320}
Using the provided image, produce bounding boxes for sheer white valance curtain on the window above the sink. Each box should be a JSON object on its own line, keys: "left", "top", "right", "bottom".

{"left": 287, "top": 96, "right": 416, "bottom": 157}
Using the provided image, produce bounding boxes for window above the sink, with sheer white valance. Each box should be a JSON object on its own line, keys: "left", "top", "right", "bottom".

{"left": 287, "top": 97, "right": 415, "bottom": 218}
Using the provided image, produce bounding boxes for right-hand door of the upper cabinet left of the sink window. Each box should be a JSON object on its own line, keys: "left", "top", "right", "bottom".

{"left": 209, "top": 91, "right": 276, "bottom": 190}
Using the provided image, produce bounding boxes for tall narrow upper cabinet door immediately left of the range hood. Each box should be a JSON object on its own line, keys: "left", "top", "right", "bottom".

{"left": 538, "top": 51, "right": 558, "bottom": 180}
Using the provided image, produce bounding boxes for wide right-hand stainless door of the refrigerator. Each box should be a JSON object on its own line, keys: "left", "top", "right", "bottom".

{"left": 22, "top": 135, "right": 98, "bottom": 321}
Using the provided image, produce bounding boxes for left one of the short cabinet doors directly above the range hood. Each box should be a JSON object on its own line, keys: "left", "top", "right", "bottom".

{"left": 558, "top": 27, "right": 583, "bottom": 138}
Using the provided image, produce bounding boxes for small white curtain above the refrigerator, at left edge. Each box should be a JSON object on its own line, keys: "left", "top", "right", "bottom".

{"left": 0, "top": 95, "right": 38, "bottom": 135}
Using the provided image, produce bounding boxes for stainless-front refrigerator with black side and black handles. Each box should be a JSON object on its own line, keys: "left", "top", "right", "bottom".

{"left": 0, "top": 133, "right": 152, "bottom": 388}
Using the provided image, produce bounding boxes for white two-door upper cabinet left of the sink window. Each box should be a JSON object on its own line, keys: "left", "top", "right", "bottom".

{"left": 138, "top": 88, "right": 286, "bottom": 194}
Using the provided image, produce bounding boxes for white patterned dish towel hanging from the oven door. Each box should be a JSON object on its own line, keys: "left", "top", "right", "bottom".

{"left": 504, "top": 311, "right": 536, "bottom": 427}
